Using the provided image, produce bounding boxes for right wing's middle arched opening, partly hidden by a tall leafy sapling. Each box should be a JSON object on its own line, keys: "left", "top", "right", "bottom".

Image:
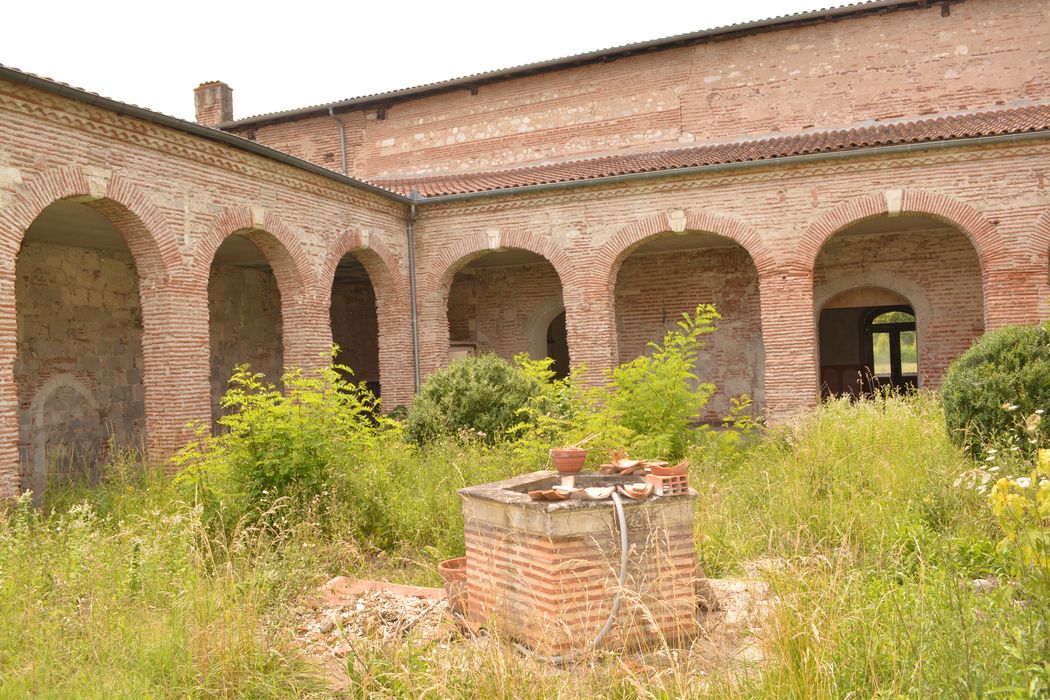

{"left": 615, "top": 231, "right": 764, "bottom": 421}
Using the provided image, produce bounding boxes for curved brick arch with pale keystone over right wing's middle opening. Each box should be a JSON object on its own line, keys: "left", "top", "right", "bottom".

{"left": 599, "top": 209, "right": 775, "bottom": 290}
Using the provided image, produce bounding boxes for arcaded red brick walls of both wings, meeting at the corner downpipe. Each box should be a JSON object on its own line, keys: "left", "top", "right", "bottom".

{"left": 0, "top": 57, "right": 1050, "bottom": 493}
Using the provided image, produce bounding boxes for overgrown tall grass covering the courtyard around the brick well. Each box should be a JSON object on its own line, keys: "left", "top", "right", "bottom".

{"left": 0, "top": 394, "right": 1050, "bottom": 698}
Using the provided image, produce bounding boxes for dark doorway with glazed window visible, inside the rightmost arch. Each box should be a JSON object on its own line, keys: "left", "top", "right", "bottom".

{"left": 819, "top": 304, "right": 919, "bottom": 398}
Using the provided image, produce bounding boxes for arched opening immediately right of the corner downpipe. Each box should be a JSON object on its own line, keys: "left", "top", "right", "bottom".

{"left": 447, "top": 248, "right": 568, "bottom": 374}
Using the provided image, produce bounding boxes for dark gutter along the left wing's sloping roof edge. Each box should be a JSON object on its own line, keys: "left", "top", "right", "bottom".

{"left": 0, "top": 65, "right": 411, "bottom": 205}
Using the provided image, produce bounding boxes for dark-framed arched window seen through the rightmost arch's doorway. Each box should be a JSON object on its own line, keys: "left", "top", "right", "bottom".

{"left": 864, "top": 306, "right": 919, "bottom": 389}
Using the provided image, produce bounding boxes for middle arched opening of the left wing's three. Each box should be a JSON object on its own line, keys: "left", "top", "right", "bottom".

{"left": 208, "top": 231, "right": 284, "bottom": 427}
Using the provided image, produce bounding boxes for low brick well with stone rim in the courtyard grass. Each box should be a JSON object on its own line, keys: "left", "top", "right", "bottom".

{"left": 460, "top": 472, "right": 698, "bottom": 655}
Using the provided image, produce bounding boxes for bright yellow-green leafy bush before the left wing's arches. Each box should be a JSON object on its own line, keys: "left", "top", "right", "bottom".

{"left": 174, "top": 365, "right": 392, "bottom": 517}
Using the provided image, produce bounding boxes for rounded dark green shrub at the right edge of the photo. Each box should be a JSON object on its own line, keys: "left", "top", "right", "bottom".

{"left": 941, "top": 325, "right": 1050, "bottom": 457}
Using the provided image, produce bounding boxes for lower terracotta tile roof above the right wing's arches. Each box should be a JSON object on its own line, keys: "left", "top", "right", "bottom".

{"left": 372, "top": 104, "right": 1050, "bottom": 197}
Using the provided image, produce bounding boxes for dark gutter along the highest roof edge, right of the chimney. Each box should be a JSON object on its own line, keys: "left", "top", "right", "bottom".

{"left": 218, "top": 0, "right": 936, "bottom": 129}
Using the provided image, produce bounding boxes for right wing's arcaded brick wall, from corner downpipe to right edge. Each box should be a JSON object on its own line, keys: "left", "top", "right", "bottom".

{"left": 409, "top": 145, "right": 1050, "bottom": 415}
